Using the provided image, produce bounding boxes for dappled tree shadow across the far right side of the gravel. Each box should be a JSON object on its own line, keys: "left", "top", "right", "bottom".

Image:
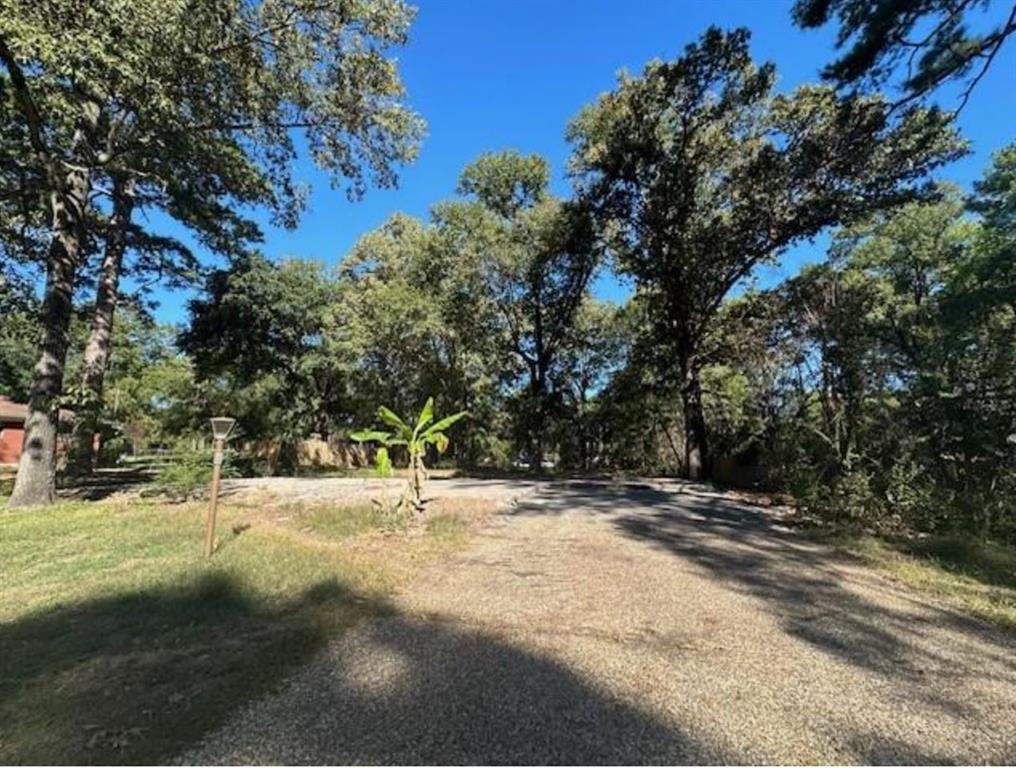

{"left": 518, "top": 482, "right": 1016, "bottom": 727}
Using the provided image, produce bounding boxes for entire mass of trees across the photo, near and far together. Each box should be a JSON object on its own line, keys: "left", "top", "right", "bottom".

{"left": 0, "top": 0, "right": 1016, "bottom": 536}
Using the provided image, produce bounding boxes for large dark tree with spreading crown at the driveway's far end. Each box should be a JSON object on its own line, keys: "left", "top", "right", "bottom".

{"left": 569, "top": 28, "right": 962, "bottom": 477}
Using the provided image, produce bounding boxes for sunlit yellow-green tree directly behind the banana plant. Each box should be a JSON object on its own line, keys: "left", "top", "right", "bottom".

{"left": 335, "top": 210, "right": 512, "bottom": 464}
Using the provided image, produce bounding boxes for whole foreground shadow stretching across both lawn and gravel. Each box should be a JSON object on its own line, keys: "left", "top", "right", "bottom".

{"left": 0, "top": 560, "right": 715, "bottom": 764}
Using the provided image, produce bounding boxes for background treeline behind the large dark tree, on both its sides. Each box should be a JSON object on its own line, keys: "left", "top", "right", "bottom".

{"left": 0, "top": 138, "right": 1016, "bottom": 537}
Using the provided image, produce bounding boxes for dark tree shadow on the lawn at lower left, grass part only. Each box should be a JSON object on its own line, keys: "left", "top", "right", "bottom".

{"left": 0, "top": 576, "right": 377, "bottom": 764}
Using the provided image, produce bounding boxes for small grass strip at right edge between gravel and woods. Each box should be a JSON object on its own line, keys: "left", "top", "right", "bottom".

{"left": 820, "top": 532, "right": 1016, "bottom": 629}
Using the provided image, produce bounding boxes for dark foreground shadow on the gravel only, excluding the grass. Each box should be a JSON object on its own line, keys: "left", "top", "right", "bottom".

{"left": 182, "top": 616, "right": 723, "bottom": 765}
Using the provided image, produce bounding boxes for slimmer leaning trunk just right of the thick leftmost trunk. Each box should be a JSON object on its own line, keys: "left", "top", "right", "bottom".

{"left": 74, "top": 179, "right": 134, "bottom": 471}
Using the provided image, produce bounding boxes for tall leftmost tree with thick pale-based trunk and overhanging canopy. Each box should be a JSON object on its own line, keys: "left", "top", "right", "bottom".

{"left": 0, "top": 0, "right": 421, "bottom": 505}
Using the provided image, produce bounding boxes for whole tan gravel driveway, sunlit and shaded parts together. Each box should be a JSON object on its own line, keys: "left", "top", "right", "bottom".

{"left": 181, "top": 482, "right": 1016, "bottom": 764}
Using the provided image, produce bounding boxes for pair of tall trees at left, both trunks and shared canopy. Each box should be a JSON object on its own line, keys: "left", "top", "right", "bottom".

{"left": 0, "top": 0, "right": 423, "bottom": 504}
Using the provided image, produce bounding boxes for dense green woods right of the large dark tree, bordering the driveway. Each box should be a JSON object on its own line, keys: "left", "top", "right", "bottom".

{"left": 690, "top": 142, "right": 1016, "bottom": 540}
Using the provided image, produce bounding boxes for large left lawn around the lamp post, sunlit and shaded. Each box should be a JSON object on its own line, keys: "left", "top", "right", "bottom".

{"left": 0, "top": 495, "right": 475, "bottom": 764}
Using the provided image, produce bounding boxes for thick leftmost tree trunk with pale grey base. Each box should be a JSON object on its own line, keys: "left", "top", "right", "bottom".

{"left": 7, "top": 164, "right": 90, "bottom": 507}
